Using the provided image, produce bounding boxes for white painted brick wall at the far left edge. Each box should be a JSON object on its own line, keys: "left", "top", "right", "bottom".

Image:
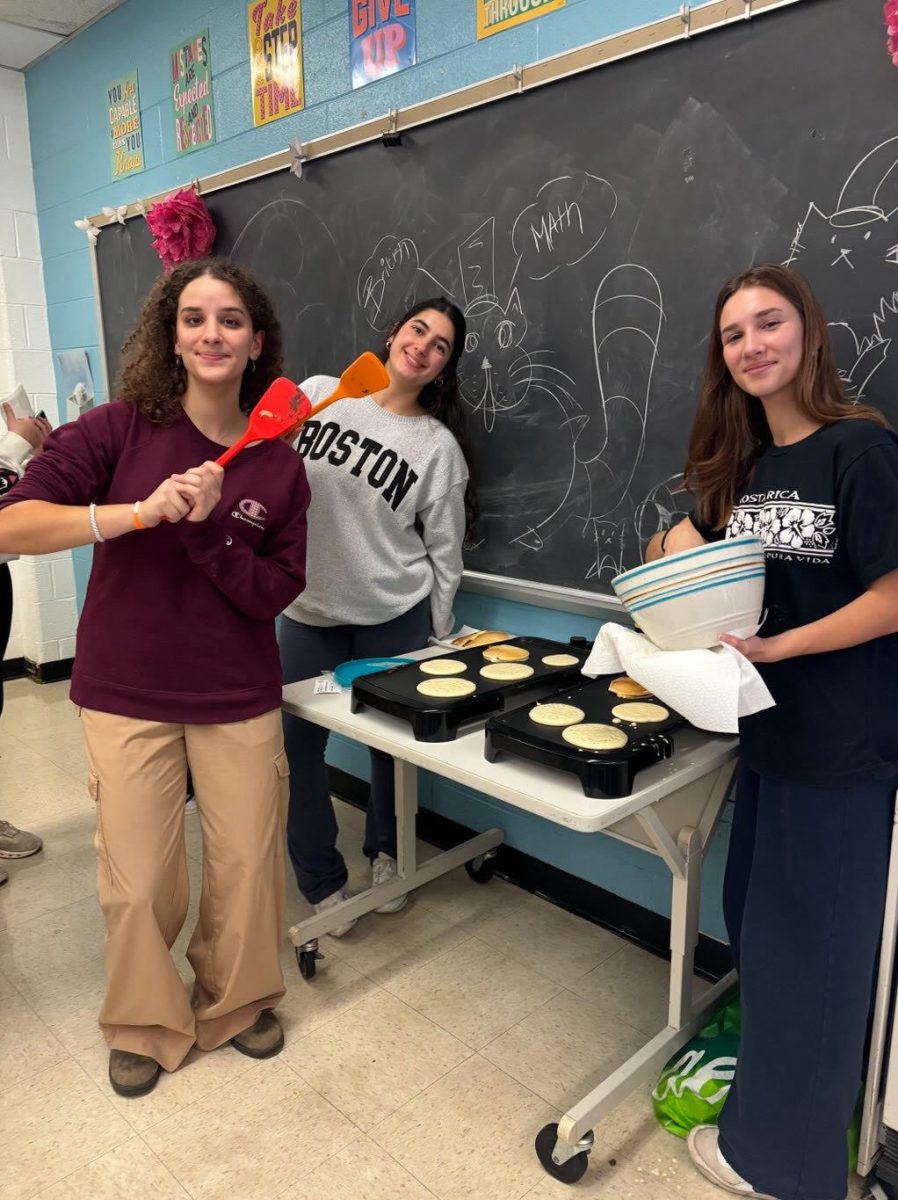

{"left": 0, "top": 67, "right": 78, "bottom": 664}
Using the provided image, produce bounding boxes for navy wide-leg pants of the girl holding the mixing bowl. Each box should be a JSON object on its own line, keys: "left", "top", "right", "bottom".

{"left": 720, "top": 767, "right": 898, "bottom": 1200}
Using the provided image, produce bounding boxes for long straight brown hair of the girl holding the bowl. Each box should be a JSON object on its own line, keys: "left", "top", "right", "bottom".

{"left": 683, "top": 263, "right": 888, "bottom": 529}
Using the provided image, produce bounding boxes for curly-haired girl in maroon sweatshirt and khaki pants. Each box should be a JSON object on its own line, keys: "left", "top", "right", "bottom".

{"left": 0, "top": 259, "right": 309, "bottom": 1096}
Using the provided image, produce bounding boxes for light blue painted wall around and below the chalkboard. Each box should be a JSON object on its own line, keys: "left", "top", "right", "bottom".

{"left": 26, "top": 0, "right": 725, "bottom": 937}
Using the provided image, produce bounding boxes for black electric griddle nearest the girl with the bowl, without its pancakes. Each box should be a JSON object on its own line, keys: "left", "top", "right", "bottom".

{"left": 484, "top": 676, "right": 684, "bottom": 799}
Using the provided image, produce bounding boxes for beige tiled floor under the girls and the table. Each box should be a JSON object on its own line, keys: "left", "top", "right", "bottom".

{"left": 0, "top": 680, "right": 860, "bottom": 1200}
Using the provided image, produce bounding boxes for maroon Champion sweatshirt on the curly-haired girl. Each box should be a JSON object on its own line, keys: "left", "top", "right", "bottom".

{"left": 0, "top": 401, "right": 309, "bottom": 725}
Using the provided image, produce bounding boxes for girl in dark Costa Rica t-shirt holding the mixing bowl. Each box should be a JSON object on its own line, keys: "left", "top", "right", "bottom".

{"left": 648, "top": 265, "right": 898, "bottom": 1200}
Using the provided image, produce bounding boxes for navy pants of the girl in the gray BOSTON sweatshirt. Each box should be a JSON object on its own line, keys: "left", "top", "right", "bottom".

{"left": 279, "top": 599, "right": 430, "bottom": 904}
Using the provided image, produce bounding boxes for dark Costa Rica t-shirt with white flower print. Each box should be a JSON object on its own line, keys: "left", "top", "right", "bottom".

{"left": 690, "top": 419, "right": 898, "bottom": 787}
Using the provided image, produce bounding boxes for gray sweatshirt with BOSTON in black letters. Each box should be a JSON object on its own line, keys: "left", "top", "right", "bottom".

{"left": 287, "top": 376, "right": 468, "bottom": 637}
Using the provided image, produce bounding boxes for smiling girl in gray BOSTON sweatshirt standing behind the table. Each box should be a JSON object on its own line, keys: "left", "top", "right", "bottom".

{"left": 280, "top": 296, "right": 473, "bottom": 937}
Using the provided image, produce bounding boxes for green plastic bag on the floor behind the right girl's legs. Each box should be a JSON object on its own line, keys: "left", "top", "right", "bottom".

{"left": 652, "top": 992, "right": 863, "bottom": 1171}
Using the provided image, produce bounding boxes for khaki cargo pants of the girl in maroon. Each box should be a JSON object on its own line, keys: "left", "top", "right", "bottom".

{"left": 80, "top": 708, "right": 288, "bottom": 1070}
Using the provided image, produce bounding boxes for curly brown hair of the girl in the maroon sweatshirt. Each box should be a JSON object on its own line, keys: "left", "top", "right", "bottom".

{"left": 113, "top": 258, "right": 283, "bottom": 425}
